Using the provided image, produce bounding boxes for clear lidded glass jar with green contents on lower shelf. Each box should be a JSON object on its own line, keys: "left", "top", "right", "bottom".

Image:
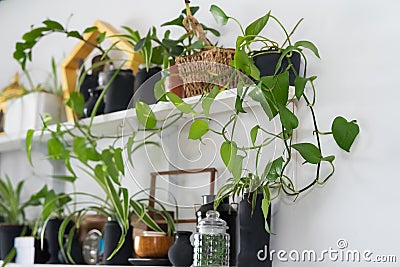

{"left": 193, "top": 210, "right": 229, "bottom": 266}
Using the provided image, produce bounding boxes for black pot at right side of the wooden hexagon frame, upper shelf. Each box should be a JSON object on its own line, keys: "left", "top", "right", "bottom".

{"left": 104, "top": 69, "right": 134, "bottom": 113}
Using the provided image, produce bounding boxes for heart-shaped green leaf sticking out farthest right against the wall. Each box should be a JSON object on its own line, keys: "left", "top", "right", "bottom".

{"left": 332, "top": 116, "right": 360, "bottom": 152}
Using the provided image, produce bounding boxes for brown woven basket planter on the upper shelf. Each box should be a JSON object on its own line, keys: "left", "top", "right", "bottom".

{"left": 175, "top": 47, "right": 237, "bottom": 97}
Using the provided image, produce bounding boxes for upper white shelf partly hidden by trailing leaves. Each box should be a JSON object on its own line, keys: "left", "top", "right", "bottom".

{"left": 0, "top": 87, "right": 294, "bottom": 153}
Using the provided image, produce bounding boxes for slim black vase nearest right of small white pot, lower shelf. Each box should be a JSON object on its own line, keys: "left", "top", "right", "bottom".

{"left": 45, "top": 219, "right": 63, "bottom": 264}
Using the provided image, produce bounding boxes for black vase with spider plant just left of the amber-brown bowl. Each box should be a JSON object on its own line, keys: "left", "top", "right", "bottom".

{"left": 103, "top": 221, "right": 133, "bottom": 265}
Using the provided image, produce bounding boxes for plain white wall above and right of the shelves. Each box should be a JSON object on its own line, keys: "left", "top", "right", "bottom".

{"left": 0, "top": 0, "right": 400, "bottom": 266}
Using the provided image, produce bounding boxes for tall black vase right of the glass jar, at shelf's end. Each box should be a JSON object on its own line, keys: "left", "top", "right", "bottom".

{"left": 237, "top": 194, "right": 272, "bottom": 267}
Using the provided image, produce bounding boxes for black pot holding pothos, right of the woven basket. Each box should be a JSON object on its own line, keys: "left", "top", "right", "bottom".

{"left": 253, "top": 51, "right": 300, "bottom": 86}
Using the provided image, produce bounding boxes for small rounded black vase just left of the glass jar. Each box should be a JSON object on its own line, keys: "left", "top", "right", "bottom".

{"left": 168, "top": 231, "right": 193, "bottom": 266}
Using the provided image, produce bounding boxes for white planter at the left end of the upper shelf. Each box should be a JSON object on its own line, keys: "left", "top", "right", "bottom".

{"left": 4, "top": 92, "right": 65, "bottom": 135}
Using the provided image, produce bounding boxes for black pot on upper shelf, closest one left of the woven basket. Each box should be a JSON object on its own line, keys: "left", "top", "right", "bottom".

{"left": 134, "top": 67, "right": 161, "bottom": 105}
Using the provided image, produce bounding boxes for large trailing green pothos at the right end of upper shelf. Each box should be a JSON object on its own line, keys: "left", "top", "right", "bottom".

{"left": 136, "top": 5, "right": 359, "bottom": 231}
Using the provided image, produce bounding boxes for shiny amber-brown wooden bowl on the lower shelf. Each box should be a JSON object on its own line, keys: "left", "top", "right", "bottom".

{"left": 134, "top": 236, "right": 174, "bottom": 258}
